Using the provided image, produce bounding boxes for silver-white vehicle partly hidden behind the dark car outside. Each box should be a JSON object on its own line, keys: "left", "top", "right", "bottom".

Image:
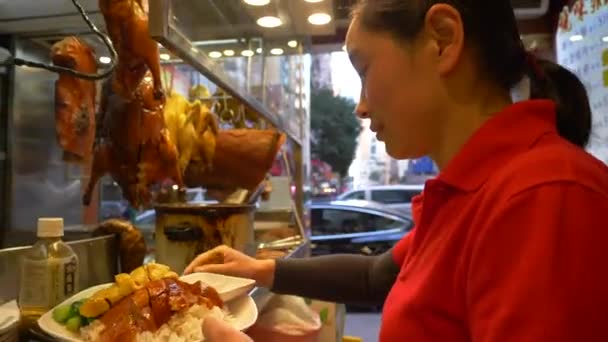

{"left": 337, "top": 184, "right": 424, "bottom": 215}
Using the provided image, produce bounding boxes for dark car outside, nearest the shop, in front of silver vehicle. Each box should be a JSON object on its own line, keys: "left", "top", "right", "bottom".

{"left": 309, "top": 200, "right": 413, "bottom": 255}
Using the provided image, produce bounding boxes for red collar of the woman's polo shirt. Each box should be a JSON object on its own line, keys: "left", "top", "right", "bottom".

{"left": 437, "top": 100, "right": 557, "bottom": 191}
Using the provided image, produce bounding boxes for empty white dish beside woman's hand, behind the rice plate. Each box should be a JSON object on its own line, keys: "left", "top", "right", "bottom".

{"left": 179, "top": 272, "right": 255, "bottom": 302}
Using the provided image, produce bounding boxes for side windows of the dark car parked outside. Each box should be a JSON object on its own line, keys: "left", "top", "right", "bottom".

{"left": 311, "top": 209, "right": 404, "bottom": 235}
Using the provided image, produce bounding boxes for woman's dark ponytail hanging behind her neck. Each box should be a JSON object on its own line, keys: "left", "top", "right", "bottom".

{"left": 527, "top": 58, "right": 592, "bottom": 148}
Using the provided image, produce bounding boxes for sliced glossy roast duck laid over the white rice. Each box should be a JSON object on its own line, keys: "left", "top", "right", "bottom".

{"left": 92, "top": 278, "right": 223, "bottom": 342}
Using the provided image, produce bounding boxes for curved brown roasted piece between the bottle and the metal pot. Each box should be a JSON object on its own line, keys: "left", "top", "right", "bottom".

{"left": 93, "top": 219, "right": 146, "bottom": 272}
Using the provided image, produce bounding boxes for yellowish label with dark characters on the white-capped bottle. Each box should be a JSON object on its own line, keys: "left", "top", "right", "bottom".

{"left": 19, "top": 256, "right": 79, "bottom": 309}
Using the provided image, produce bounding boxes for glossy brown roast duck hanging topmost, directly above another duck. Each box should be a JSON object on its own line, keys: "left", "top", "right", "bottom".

{"left": 99, "top": 0, "right": 163, "bottom": 99}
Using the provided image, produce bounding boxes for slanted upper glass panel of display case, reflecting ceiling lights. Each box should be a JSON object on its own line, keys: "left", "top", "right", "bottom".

{"left": 159, "top": 0, "right": 309, "bottom": 142}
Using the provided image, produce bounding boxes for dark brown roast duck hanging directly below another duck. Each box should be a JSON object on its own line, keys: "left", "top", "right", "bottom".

{"left": 83, "top": 73, "right": 182, "bottom": 208}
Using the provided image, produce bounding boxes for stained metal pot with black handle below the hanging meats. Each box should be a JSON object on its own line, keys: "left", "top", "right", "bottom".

{"left": 155, "top": 204, "right": 256, "bottom": 273}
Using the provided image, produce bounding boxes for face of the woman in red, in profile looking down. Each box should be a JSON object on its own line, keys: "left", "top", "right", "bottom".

{"left": 346, "top": 18, "right": 441, "bottom": 159}
